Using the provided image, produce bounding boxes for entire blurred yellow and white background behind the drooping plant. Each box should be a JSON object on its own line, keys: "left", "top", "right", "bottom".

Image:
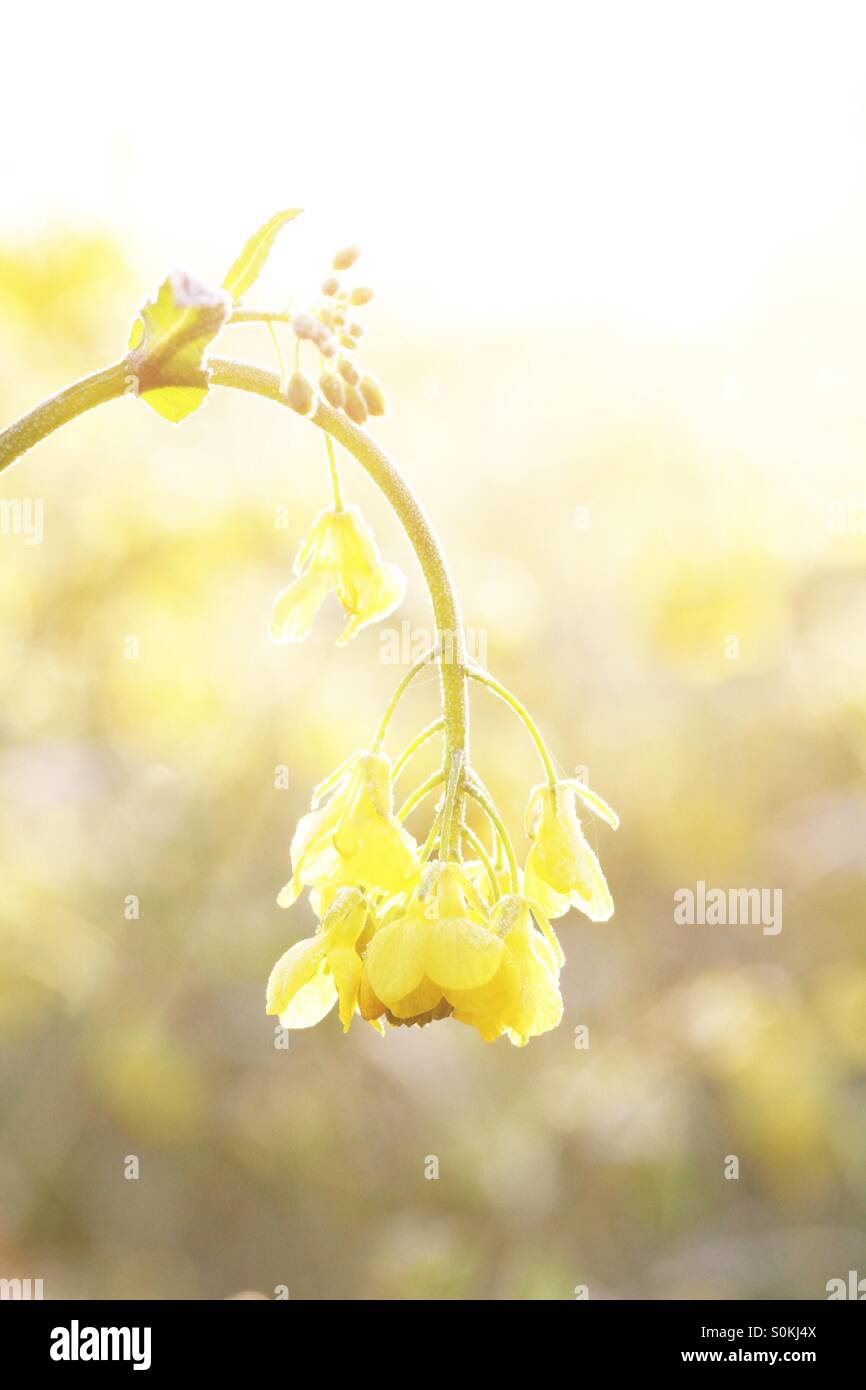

{"left": 0, "top": 0, "right": 866, "bottom": 1300}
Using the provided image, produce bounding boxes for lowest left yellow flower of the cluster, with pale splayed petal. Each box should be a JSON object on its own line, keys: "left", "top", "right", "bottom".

{"left": 267, "top": 888, "right": 370, "bottom": 1031}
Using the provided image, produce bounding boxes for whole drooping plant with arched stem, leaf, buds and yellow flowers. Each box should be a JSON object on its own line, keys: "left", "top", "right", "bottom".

{"left": 0, "top": 209, "right": 617, "bottom": 1045}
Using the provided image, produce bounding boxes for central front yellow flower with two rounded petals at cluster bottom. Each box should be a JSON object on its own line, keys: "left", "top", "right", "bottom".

{"left": 360, "top": 863, "right": 505, "bottom": 1023}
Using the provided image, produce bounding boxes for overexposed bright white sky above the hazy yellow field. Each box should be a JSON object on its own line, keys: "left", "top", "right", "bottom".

{"left": 0, "top": 0, "right": 866, "bottom": 336}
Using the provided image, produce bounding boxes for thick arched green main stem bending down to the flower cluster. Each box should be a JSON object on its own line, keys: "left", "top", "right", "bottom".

{"left": 0, "top": 353, "right": 468, "bottom": 855}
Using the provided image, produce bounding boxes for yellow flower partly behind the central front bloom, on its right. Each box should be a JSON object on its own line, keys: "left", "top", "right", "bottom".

{"left": 448, "top": 894, "right": 564, "bottom": 1047}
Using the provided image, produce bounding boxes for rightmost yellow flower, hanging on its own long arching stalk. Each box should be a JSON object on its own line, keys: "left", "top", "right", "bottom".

{"left": 524, "top": 781, "right": 620, "bottom": 922}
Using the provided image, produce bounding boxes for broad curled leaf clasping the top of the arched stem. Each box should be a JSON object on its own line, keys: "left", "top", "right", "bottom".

{"left": 129, "top": 271, "right": 231, "bottom": 424}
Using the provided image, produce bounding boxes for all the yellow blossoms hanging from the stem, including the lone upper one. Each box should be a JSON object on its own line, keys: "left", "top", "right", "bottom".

{"left": 267, "top": 483, "right": 617, "bottom": 1045}
